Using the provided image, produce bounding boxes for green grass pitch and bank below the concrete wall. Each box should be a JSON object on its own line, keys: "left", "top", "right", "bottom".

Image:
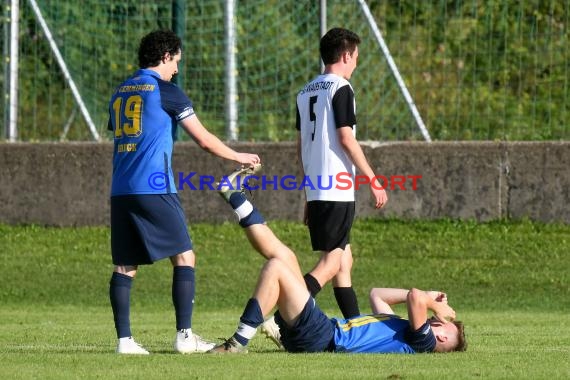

{"left": 0, "top": 220, "right": 570, "bottom": 379}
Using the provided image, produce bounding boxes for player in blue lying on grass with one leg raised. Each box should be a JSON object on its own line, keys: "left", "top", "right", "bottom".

{"left": 206, "top": 168, "right": 466, "bottom": 353}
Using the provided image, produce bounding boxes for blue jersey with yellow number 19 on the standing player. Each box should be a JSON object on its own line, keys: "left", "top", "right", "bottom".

{"left": 109, "top": 69, "right": 194, "bottom": 196}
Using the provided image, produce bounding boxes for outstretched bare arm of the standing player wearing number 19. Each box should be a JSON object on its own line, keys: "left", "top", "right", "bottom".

{"left": 180, "top": 114, "right": 261, "bottom": 166}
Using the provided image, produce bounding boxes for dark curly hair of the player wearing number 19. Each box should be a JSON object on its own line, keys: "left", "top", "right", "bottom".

{"left": 139, "top": 30, "right": 182, "bottom": 69}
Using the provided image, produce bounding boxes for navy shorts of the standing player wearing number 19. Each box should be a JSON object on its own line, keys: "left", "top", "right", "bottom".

{"left": 111, "top": 194, "right": 192, "bottom": 265}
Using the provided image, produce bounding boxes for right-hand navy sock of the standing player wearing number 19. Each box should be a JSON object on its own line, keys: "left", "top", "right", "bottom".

{"left": 172, "top": 266, "right": 196, "bottom": 330}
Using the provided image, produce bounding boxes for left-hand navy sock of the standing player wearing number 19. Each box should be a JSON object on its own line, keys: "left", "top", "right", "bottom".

{"left": 109, "top": 272, "right": 133, "bottom": 338}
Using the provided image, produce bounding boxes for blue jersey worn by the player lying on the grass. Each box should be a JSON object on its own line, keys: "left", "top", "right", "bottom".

{"left": 332, "top": 314, "right": 435, "bottom": 354}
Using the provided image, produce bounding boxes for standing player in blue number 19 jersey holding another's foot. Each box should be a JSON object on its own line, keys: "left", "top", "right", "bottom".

{"left": 109, "top": 30, "right": 260, "bottom": 354}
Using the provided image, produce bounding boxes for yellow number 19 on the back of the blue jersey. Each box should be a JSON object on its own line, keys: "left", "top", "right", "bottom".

{"left": 113, "top": 95, "right": 143, "bottom": 139}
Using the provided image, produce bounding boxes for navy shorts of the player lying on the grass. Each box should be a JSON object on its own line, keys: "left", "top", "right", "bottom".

{"left": 275, "top": 297, "right": 335, "bottom": 352}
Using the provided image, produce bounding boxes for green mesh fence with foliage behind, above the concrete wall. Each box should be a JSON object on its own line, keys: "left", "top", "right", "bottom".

{"left": 0, "top": 0, "right": 570, "bottom": 141}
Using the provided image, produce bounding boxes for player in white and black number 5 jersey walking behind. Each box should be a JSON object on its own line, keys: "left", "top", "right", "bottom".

{"left": 296, "top": 28, "right": 388, "bottom": 318}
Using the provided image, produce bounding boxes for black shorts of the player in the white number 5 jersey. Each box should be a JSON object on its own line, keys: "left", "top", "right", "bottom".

{"left": 307, "top": 201, "right": 355, "bottom": 252}
